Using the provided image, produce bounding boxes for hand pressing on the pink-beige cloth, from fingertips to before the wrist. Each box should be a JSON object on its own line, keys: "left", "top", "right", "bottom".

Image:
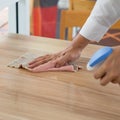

{"left": 29, "top": 47, "right": 81, "bottom": 69}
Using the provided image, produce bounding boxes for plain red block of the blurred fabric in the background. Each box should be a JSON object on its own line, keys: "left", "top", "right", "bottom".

{"left": 41, "top": 6, "right": 57, "bottom": 38}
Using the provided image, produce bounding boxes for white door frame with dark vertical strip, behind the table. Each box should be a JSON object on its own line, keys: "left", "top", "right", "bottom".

{"left": 0, "top": 0, "right": 30, "bottom": 35}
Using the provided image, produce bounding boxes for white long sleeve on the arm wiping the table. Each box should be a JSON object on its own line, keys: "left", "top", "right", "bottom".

{"left": 80, "top": 0, "right": 120, "bottom": 42}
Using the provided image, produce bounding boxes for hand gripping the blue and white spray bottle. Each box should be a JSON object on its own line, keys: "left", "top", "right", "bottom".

{"left": 94, "top": 46, "right": 120, "bottom": 86}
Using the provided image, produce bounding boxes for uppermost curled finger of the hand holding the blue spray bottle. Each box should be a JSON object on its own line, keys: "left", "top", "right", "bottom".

{"left": 94, "top": 66, "right": 106, "bottom": 79}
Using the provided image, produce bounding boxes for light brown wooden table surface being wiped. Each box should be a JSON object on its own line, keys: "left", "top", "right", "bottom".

{"left": 0, "top": 34, "right": 120, "bottom": 120}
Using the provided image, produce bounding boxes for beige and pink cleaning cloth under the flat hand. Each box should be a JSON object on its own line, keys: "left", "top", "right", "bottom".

{"left": 8, "top": 53, "right": 81, "bottom": 72}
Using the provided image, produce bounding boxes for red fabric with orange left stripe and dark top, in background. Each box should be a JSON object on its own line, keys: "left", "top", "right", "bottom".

{"left": 31, "top": 0, "right": 58, "bottom": 38}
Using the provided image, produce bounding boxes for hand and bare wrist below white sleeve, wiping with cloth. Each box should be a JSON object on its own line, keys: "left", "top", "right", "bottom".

{"left": 29, "top": 34, "right": 89, "bottom": 69}
